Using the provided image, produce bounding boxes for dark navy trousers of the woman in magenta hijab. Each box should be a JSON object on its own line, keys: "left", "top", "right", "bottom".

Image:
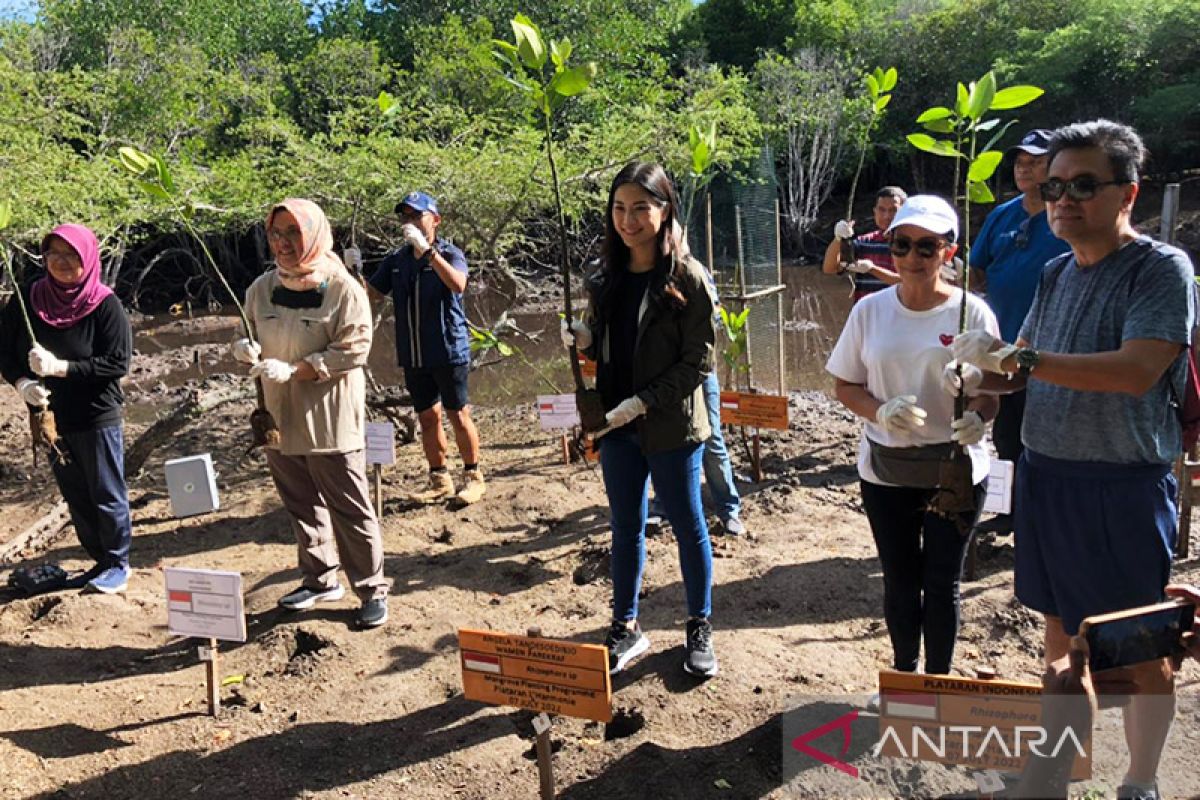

{"left": 50, "top": 425, "right": 133, "bottom": 569}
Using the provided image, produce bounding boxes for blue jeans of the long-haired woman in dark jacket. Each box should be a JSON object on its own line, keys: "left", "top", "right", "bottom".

{"left": 600, "top": 426, "right": 713, "bottom": 622}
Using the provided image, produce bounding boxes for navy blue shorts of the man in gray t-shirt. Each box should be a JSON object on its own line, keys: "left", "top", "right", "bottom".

{"left": 1013, "top": 449, "right": 1177, "bottom": 636}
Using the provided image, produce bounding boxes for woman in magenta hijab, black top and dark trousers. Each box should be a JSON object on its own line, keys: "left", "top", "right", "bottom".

{"left": 0, "top": 224, "right": 133, "bottom": 594}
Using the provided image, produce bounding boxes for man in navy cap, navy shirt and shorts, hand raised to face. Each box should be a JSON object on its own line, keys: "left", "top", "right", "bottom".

{"left": 370, "top": 192, "right": 486, "bottom": 504}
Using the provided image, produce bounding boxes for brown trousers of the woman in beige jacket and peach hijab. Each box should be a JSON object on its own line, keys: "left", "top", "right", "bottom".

{"left": 266, "top": 449, "right": 389, "bottom": 601}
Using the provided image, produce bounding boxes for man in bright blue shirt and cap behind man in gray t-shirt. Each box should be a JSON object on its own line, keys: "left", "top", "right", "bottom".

{"left": 971, "top": 130, "right": 1070, "bottom": 533}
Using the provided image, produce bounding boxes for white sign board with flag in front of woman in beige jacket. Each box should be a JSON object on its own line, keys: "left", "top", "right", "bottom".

{"left": 163, "top": 566, "right": 246, "bottom": 642}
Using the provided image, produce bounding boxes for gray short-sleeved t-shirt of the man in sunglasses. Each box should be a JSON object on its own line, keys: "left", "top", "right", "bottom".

{"left": 1021, "top": 236, "right": 1196, "bottom": 464}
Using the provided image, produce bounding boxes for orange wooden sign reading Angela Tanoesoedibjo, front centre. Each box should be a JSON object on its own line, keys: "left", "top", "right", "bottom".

{"left": 458, "top": 630, "right": 612, "bottom": 722}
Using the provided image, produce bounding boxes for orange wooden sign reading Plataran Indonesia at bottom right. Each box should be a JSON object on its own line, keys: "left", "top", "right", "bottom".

{"left": 877, "top": 670, "right": 1092, "bottom": 780}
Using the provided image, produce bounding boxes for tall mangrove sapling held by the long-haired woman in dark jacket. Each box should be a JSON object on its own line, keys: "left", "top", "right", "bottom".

{"left": 492, "top": 14, "right": 607, "bottom": 432}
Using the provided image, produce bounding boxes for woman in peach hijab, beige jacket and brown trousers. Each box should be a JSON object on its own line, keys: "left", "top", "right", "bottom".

{"left": 233, "top": 198, "right": 389, "bottom": 628}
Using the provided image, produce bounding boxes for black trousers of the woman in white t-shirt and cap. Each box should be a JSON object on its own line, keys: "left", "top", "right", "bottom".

{"left": 860, "top": 481, "right": 986, "bottom": 674}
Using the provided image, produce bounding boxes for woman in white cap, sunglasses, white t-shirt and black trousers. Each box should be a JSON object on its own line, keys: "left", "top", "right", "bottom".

{"left": 826, "top": 194, "right": 1000, "bottom": 674}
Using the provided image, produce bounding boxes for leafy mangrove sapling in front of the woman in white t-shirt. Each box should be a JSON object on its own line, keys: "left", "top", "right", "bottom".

{"left": 907, "top": 71, "right": 1044, "bottom": 529}
